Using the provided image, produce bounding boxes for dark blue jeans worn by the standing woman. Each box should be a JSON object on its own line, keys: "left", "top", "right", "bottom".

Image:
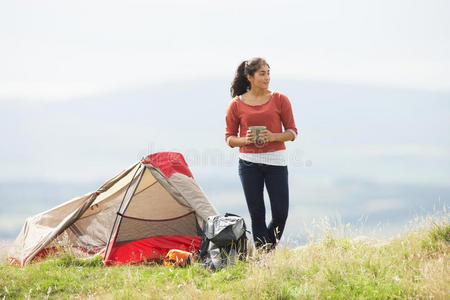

{"left": 239, "top": 159, "right": 289, "bottom": 247}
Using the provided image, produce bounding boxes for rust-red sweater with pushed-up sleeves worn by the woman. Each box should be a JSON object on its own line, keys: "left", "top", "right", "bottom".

{"left": 225, "top": 92, "right": 298, "bottom": 153}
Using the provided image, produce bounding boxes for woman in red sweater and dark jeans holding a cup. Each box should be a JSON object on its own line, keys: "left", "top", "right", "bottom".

{"left": 225, "top": 57, "right": 297, "bottom": 249}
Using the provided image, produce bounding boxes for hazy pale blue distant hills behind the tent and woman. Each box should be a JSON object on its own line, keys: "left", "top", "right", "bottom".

{"left": 0, "top": 79, "right": 450, "bottom": 239}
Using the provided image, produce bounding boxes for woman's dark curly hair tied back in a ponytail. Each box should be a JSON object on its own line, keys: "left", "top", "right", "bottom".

{"left": 230, "top": 57, "right": 270, "bottom": 97}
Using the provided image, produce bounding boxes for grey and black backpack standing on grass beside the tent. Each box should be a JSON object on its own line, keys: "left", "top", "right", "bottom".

{"left": 198, "top": 213, "right": 247, "bottom": 270}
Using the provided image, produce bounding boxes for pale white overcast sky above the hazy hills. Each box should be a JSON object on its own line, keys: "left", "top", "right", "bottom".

{"left": 0, "top": 0, "right": 450, "bottom": 100}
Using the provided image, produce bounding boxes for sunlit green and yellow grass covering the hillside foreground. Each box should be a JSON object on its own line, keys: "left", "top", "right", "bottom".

{"left": 0, "top": 215, "right": 450, "bottom": 299}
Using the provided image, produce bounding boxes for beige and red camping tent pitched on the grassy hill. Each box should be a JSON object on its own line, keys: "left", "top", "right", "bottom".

{"left": 11, "top": 152, "right": 218, "bottom": 266}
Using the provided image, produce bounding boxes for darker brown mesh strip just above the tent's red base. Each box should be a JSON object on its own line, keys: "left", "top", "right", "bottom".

{"left": 115, "top": 211, "right": 201, "bottom": 243}
